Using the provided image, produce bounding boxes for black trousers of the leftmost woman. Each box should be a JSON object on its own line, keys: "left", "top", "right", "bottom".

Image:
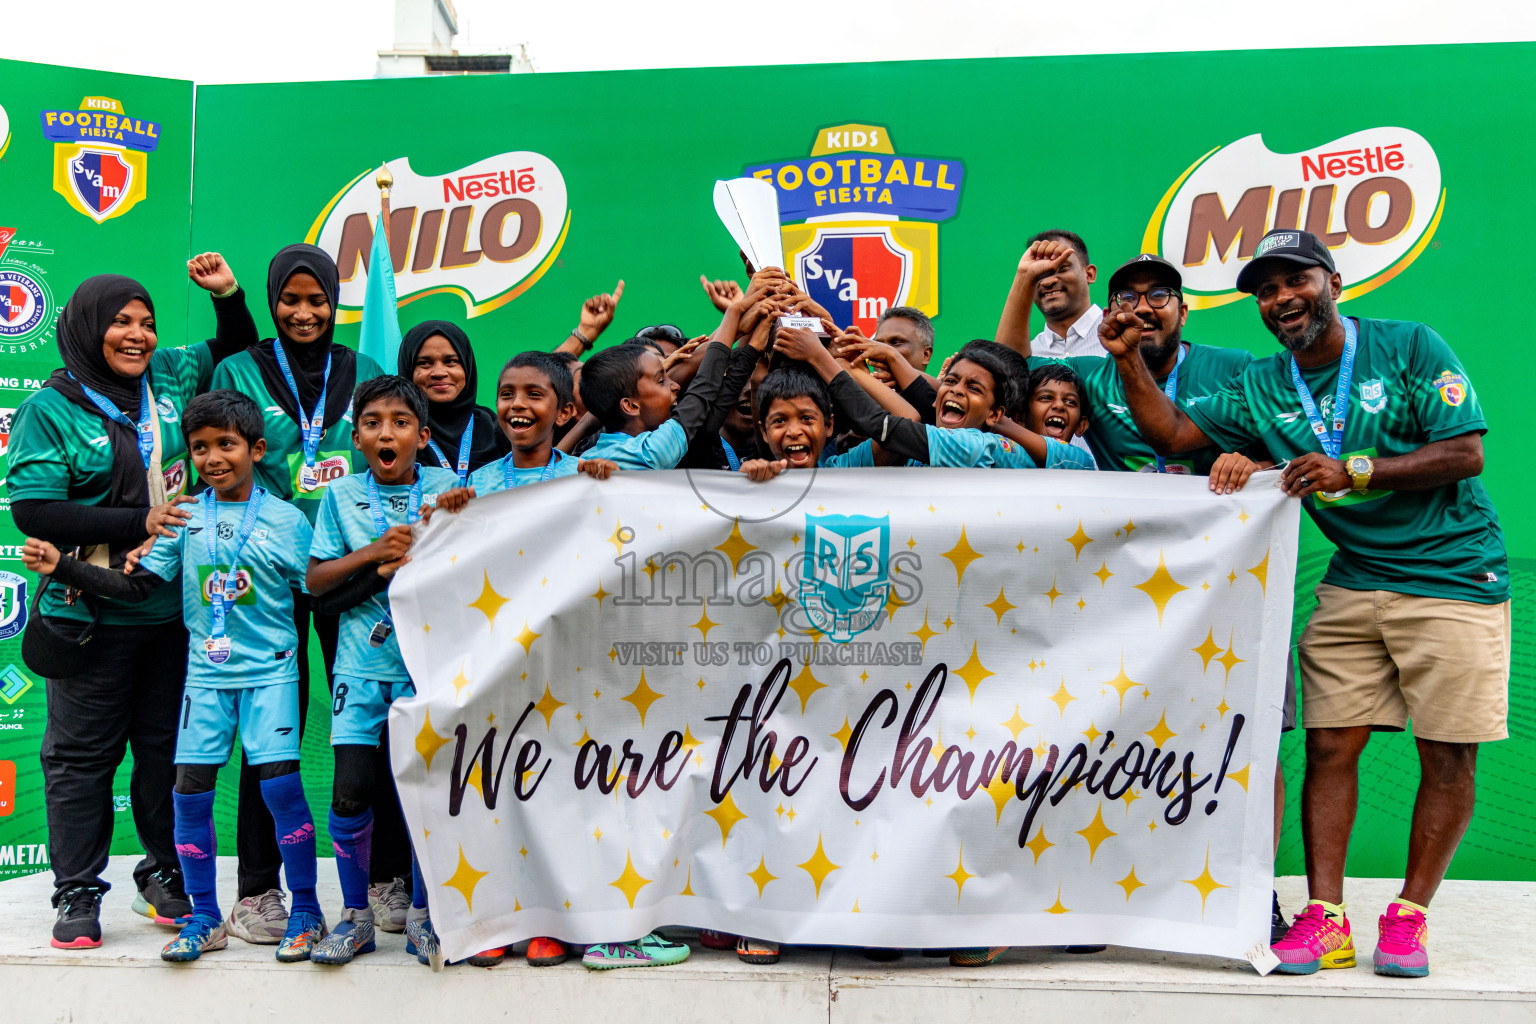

{"left": 38, "top": 622, "right": 187, "bottom": 903}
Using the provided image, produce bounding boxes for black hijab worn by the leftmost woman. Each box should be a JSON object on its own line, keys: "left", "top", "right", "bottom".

{"left": 43, "top": 273, "right": 155, "bottom": 508}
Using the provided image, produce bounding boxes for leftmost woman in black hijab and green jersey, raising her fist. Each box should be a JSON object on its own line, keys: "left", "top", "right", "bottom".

{"left": 6, "top": 260, "right": 244, "bottom": 949}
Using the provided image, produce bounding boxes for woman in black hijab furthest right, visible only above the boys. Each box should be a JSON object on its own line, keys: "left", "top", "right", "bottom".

{"left": 398, "top": 319, "right": 511, "bottom": 487}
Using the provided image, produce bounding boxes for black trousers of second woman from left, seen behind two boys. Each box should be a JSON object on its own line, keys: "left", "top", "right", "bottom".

{"left": 235, "top": 591, "right": 410, "bottom": 900}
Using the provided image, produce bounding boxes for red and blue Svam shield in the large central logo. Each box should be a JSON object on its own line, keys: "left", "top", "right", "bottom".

{"left": 794, "top": 227, "right": 912, "bottom": 336}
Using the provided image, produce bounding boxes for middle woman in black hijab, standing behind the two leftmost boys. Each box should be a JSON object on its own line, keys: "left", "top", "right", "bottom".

{"left": 214, "top": 244, "right": 387, "bottom": 944}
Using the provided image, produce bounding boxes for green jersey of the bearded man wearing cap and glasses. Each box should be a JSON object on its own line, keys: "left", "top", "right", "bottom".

{"left": 1029, "top": 344, "right": 1253, "bottom": 476}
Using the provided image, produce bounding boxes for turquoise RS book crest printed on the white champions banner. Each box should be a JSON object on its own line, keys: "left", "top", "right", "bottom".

{"left": 800, "top": 516, "right": 891, "bottom": 643}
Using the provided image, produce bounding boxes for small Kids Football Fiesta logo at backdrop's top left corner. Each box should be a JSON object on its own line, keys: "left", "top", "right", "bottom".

{"left": 38, "top": 97, "right": 160, "bottom": 224}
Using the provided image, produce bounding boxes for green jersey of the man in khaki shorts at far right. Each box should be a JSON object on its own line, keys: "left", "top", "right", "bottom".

{"left": 1184, "top": 319, "right": 1510, "bottom": 605}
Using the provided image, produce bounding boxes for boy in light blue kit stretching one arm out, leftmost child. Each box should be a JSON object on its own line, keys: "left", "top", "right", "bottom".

{"left": 23, "top": 390, "right": 326, "bottom": 963}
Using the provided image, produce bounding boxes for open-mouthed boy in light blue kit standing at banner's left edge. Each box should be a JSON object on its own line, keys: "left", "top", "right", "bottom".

{"left": 307, "top": 375, "right": 468, "bottom": 969}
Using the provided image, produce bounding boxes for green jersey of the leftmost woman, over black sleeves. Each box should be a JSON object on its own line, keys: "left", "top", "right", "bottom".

{"left": 5, "top": 342, "right": 214, "bottom": 625}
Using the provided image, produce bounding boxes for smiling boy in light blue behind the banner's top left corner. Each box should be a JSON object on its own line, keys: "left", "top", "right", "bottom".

{"left": 470, "top": 352, "right": 619, "bottom": 496}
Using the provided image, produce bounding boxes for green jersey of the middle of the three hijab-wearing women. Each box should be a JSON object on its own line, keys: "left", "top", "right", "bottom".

{"left": 214, "top": 352, "right": 384, "bottom": 525}
